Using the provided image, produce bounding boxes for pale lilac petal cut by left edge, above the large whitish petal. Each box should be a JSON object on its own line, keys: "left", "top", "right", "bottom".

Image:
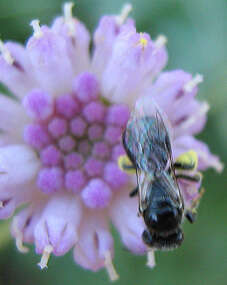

{"left": 0, "top": 94, "right": 28, "bottom": 138}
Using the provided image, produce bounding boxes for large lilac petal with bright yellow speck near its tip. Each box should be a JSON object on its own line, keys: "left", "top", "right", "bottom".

{"left": 102, "top": 27, "right": 167, "bottom": 105}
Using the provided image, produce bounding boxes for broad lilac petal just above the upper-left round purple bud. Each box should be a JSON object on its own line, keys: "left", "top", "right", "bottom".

{"left": 26, "top": 22, "right": 73, "bottom": 95}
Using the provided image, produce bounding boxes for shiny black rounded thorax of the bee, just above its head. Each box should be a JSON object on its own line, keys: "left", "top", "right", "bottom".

{"left": 143, "top": 198, "right": 183, "bottom": 235}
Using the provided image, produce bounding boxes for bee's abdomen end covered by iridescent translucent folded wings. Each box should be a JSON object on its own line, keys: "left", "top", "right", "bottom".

{"left": 125, "top": 96, "right": 174, "bottom": 173}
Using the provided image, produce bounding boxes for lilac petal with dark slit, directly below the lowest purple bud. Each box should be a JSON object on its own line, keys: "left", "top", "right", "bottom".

{"left": 74, "top": 211, "right": 113, "bottom": 271}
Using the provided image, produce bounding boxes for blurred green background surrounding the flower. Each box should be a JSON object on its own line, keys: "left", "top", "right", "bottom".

{"left": 0, "top": 0, "right": 227, "bottom": 285}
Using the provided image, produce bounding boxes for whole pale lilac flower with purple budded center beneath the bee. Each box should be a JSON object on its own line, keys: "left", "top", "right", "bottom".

{"left": 0, "top": 3, "right": 222, "bottom": 279}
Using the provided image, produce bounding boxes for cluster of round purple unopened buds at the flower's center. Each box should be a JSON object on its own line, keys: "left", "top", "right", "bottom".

{"left": 24, "top": 73, "right": 129, "bottom": 208}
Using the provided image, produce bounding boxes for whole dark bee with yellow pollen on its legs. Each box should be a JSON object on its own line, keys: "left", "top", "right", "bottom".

{"left": 120, "top": 98, "right": 201, "bottom": 250}
